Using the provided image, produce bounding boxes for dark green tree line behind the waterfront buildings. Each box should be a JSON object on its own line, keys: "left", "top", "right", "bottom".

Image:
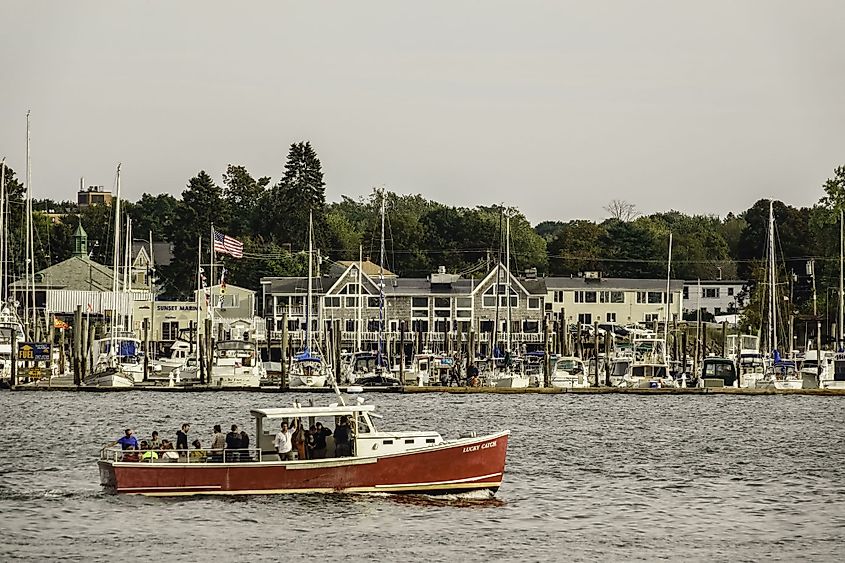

{"left": 1, "top": 142, "right": 845, "bottom": 324}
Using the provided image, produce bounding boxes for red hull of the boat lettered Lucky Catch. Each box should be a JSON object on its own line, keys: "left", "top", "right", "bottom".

{"left": 99, "top": 432, "right": 508, "bottom": 496}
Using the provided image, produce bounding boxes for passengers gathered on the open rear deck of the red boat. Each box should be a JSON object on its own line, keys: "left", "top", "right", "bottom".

{"left": 116, "top": 422, "right": 252, "bottom": 462}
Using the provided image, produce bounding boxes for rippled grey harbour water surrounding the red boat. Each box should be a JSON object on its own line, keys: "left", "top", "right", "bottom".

{"left": 0, "top": 392, "right": 845, "bottom": 561}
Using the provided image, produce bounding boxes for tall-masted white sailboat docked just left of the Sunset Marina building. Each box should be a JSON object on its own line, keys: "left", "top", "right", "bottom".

{"left": 85, "top": 164, "right": 144, "bottom": 387}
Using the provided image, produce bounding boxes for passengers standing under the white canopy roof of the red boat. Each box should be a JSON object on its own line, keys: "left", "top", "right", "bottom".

{"left": 273, "top": 416, "right": 353, "bottom": 461}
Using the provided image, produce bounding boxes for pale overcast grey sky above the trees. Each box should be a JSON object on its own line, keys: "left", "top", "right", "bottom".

{"left": 0, "top": 0, "right": 845, "bottom": 223}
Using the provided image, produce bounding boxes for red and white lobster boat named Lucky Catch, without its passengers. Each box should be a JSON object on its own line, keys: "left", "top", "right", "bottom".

{"left": 99, "top": 399, "right": 510, "bottom": 496}
